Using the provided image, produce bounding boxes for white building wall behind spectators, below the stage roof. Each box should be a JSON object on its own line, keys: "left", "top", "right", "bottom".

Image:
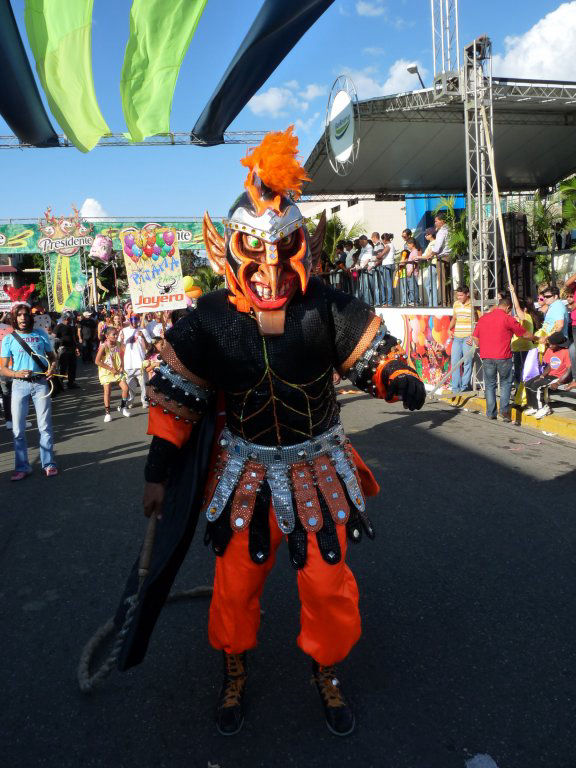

{"left": 298, "top": 198, "right": 406, "bottom": 243}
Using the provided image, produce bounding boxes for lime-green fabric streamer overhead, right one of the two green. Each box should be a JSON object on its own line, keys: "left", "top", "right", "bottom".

{"left": 120, "top": 0, "right": 207, "bottom": 141}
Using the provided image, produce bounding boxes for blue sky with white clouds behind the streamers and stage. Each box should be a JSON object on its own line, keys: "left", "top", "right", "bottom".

{"left": 0, "top": 0, "right": 576, "bottom": 218}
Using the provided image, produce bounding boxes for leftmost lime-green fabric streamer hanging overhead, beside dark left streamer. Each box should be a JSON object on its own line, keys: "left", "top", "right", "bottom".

{"left": 25, "top": 0, "right": 110, "bottom": 152}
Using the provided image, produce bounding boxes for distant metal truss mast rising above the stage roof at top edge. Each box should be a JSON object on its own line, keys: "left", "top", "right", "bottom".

{"left": 430, "top": 0, "right": 460, "bottom": 98}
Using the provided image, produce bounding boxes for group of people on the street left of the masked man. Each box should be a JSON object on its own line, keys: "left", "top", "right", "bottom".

{"left": 0, "top": 302, "right": 187, "bottom": 481}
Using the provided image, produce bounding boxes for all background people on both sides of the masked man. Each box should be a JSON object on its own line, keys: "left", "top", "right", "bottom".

{"left": 0, "top": 262, "right": 576, "bottom": 480}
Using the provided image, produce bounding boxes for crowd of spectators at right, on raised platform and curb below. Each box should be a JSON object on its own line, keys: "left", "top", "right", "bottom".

{"left": 323, "top": 212, "right": 576, "bottom": 421}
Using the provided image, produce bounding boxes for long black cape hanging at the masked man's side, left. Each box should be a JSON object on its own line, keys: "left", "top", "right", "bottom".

{"left": 114, "top": 408, "right": 216, "bottom": 671}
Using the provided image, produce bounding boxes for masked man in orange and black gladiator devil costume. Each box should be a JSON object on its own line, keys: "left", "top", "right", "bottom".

{"left": 116, "top": 128, "right": 425, "bottom": 735}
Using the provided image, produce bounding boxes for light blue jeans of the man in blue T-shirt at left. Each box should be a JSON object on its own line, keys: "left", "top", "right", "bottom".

{"left": 12, "top": 379, "right": 56, "bottom": 472}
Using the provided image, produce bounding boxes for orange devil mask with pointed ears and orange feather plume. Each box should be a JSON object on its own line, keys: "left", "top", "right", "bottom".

{"left": 203, "top": 126, "right": 325, "bottom": 335}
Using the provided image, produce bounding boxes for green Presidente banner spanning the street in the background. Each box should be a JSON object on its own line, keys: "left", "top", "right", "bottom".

{"left": 0, "top": 217, "right": 224, "bottom": 254}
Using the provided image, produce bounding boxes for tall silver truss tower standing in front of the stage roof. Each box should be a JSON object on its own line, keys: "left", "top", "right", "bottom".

{"left": 461, "top": 37, "right": 498, "bottom": 312}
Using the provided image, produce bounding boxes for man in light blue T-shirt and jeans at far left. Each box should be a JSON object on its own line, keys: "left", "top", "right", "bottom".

{"left": 0, "top": 303, "right": 58, "bottom": 481}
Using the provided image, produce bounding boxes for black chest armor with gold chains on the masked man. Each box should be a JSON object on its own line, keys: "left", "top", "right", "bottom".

{"left": 162, "top": 279, "right": 370, "bottom": 445}
